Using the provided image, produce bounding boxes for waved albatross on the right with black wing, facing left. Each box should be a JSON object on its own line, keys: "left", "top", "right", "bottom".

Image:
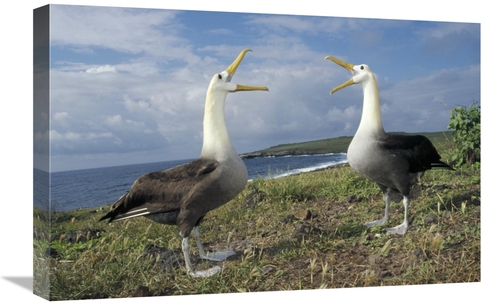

{"left": 325, "top": 56, "right": 452, "bottom": 235}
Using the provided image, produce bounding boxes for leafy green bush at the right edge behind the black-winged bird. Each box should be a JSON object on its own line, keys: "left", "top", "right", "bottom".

{"left": 447, "top": 101, "right": 481, "bottom": 166}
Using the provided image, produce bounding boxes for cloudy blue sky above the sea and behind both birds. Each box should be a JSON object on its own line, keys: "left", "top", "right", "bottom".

{"left": 35, "top": 5, "right": 481, "bottom": 171}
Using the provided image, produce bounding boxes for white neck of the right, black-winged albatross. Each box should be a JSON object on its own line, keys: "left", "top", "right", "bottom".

{"left": 356, "top": 74, "right": 385, "bottom": 135}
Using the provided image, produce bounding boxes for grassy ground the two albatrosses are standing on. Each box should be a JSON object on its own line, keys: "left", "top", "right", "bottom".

{"left": 33, "top": 150, "right": 481, "bottom": 300}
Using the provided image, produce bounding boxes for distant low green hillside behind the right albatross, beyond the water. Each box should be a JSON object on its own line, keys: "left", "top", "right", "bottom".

{"left": 241, "top": 131, "right": 452, "bottom": 158}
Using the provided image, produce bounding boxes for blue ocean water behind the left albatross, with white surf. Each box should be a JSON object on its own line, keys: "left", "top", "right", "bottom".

{"left": 33, "top": 153, "right": 347, "bottom": 212}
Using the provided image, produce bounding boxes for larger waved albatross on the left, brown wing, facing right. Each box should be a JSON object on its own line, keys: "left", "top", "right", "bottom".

{"left": 100, "top": 49, "right": 268, "bottom": 277}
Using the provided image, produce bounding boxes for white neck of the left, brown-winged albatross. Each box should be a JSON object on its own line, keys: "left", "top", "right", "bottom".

{"left": 200, "top": 91, "right": 238, "bottom": 161}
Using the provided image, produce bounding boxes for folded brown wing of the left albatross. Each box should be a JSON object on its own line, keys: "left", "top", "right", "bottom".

{"left": 100, "top": 159, "right": 219, "bottom": 222}
